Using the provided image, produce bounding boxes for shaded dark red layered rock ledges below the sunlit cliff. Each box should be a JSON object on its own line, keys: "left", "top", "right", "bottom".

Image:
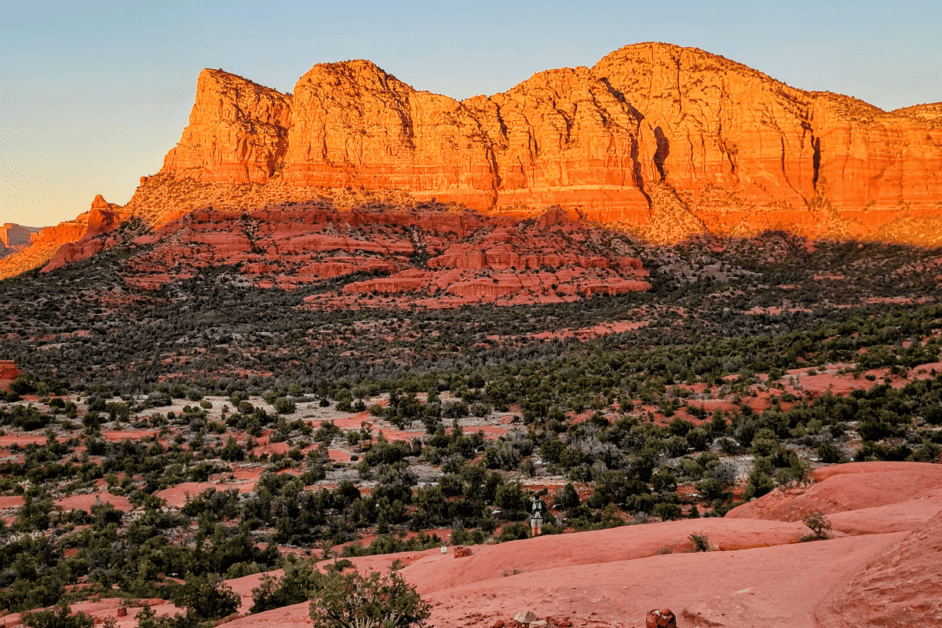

{"left": 110, "top": 204, "right": 651, "bottom": 308}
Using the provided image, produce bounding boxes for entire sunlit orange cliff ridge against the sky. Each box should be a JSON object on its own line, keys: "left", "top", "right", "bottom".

{"left": 0, "top": 43, "right": 942, "bottom": 277}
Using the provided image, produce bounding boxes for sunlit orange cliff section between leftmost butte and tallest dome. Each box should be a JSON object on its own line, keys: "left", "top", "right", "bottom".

{"left": 285, "top": 61, "right": 649, "bottom": 224}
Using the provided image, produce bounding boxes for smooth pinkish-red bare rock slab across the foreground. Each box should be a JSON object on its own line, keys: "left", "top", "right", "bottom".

{"left": 216, "top": 463, "right": 942, "bottom": 628}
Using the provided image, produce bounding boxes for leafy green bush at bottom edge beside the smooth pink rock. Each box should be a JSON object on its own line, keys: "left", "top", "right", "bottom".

{"left": 310, "top": 571, "right": 431, "bottom": 628}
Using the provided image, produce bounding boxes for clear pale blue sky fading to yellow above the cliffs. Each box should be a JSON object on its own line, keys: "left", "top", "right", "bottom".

{"left": 0, "top": 0, "right": 942, "bottom": 227}
